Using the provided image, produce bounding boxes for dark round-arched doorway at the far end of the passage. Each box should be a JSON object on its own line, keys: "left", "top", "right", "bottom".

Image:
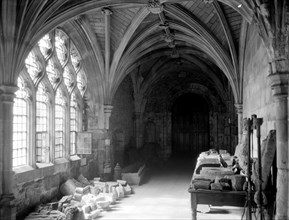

{"left": 172, "top": 93, "right": 209, "bottom": 156}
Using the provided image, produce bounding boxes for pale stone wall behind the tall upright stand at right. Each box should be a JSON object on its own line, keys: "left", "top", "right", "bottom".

{"left": 243, "top": 21, "right": 275, "bottom": 156}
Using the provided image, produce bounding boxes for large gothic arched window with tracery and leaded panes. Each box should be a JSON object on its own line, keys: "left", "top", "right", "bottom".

{"left": 13, "top": 28, "right": 87, "bottom": 168}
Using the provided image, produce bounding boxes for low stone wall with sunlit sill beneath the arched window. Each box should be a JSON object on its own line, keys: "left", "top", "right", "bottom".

{"left": 14, "top": 154, "right": 99, "bottom": 219}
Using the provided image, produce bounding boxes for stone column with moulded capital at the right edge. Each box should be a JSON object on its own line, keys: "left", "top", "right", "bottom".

{"left": 268, "top": 73, "right": 289, "bottom": 220}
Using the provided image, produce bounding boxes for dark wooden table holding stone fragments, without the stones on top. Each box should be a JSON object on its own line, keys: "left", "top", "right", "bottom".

{"left": 188, "top": 188, "right": 247, "bottom": 220}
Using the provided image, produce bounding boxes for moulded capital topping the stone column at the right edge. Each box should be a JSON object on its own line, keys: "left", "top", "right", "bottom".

{"left": 268, "top": 72, "right": 289, "bottom": 97}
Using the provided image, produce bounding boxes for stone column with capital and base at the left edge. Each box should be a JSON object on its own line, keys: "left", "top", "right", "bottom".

{"left": 0, "top": 86, "right": 18, "bottom": 220}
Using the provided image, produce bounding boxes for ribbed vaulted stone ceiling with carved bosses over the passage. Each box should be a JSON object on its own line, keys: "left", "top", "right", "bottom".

{"left": 3, "top": 0, "right": 253, "bottom": 106}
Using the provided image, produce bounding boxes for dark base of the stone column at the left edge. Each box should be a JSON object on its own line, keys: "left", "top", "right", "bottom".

{"left": 0, "top": 194, "right": 16, "bottom": 220}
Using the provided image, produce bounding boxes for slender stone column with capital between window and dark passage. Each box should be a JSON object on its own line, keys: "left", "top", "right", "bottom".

{"left": 104, "top": 105, "right": 113, "bottom": 179}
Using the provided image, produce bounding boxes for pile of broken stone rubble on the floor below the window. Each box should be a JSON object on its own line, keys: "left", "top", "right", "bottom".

{"left": 25, "top": 175, "right": 132, "bottom": 220}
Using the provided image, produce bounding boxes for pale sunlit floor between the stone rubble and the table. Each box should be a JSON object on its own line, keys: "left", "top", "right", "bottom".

{"left": 99, "top": 158, "right": 245, "bottom": 220}
